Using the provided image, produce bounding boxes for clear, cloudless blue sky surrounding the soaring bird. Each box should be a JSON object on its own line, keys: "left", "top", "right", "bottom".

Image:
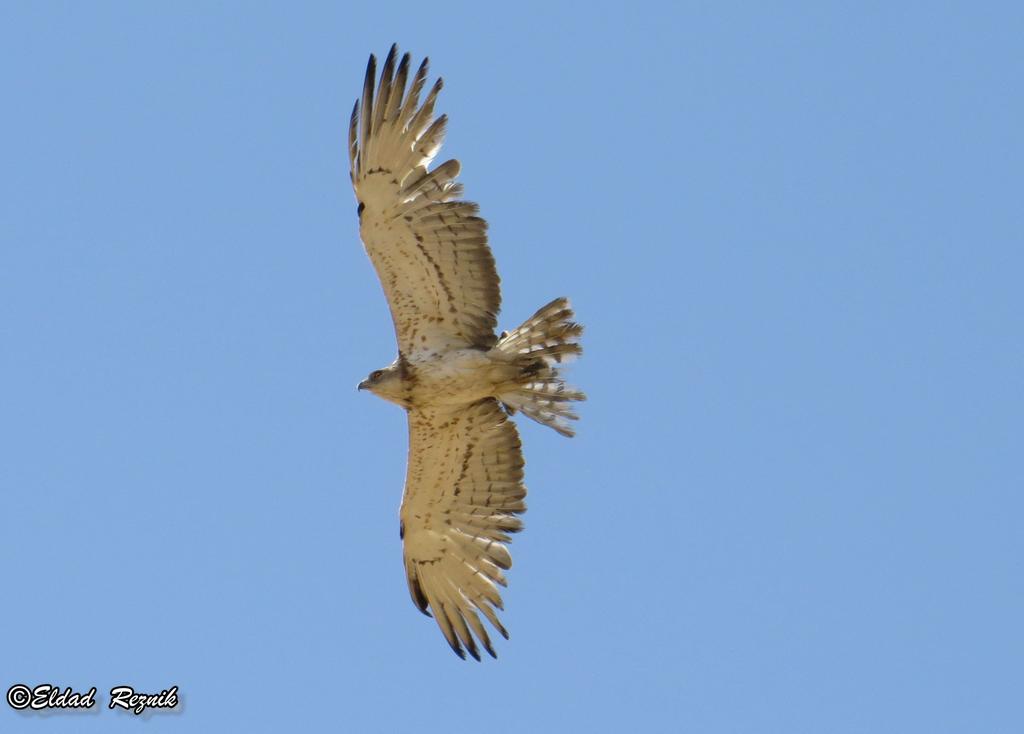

{"left": 0, "top": 2, "right": 1024, "bottom": 734}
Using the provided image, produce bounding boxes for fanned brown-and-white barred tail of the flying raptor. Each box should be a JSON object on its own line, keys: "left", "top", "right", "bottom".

{"left": 494, "top": 298, "right": 587, "bottom": 436}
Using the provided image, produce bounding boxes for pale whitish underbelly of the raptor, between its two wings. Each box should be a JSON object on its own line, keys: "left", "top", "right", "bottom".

{"left": 410, "top": 349, "right": 502, "bottom": 406}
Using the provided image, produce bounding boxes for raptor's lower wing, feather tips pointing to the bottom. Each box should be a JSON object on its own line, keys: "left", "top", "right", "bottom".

{"left": 401, "top": 398, "right": 526, "bottom": 660}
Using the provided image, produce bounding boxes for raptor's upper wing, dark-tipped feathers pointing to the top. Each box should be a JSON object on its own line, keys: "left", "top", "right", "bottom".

{"left": 348, "top": 46, "right": 501, "bottom": 356}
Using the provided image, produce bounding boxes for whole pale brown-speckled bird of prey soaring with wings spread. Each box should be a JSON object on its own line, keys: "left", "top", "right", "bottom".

{"left": 348, "top": 46, "right": 585, "bottom": 660}
